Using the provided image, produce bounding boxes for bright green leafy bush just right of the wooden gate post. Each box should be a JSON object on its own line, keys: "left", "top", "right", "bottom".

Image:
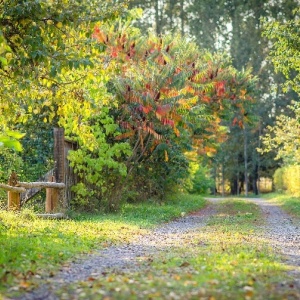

{"left": 67, "top": 107, "right": 131, "bottom": 210}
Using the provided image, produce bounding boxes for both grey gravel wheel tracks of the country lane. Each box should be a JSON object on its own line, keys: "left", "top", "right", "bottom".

{"left": 12, "top": 198, "right": 300, "bottom": 300}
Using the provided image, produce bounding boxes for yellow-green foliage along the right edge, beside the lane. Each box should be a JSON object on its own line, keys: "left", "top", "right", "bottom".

{"left": 259, "top": 8, "right": 300, "bottom": 196}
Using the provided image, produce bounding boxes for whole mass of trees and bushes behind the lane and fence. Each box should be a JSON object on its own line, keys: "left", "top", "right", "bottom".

{"left": 0, "top": 0, "right": 300, "bottom": 210}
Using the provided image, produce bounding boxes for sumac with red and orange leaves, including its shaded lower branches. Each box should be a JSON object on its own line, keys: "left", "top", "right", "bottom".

{"left": 93, "top": 24, "right": 253, "bottom": 203}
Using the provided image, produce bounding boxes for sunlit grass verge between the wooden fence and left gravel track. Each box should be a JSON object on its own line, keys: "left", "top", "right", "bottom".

{"left": 0, "top": 195, "right": 205, "bottom": 299}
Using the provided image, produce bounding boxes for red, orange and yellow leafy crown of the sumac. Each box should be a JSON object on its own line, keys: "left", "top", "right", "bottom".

{"left": 93, "top": 23, "right": 253, "bottom": 154}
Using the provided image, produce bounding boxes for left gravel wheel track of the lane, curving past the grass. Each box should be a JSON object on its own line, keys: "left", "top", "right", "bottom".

{"left": 17, "top": 200, "right": 215, "bottom": 300}
